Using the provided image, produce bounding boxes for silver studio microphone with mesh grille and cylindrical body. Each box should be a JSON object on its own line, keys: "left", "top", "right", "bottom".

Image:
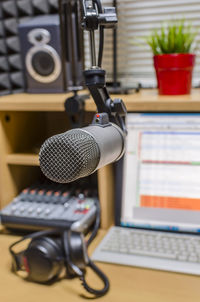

{"left": 39, "top": 114, "right": 125, "bottom": 183}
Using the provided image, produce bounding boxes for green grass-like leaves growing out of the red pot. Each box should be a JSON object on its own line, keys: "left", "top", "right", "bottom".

{"left": 146, "top": 20, "right": 197, "bottom": 55}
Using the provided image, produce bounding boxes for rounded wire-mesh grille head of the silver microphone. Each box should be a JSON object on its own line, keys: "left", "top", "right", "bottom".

{"left": 39, "top": 129, "right": 100, "bottom": 183}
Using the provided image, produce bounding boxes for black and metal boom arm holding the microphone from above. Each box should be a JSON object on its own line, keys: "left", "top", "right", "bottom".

{"left": 81, "top": 0, "right": 127, "bottom": 134}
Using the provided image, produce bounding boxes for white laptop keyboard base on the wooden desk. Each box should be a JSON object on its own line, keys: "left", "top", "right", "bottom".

{"left": 92, "top": 227, "right": 200, "bottom": 275}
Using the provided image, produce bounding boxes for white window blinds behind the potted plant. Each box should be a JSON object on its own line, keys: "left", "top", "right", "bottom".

{"left": 85, "top": 0, "right": 200, "bottom": 87}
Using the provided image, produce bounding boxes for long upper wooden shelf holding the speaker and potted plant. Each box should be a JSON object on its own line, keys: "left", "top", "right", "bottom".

{"left": 0, "top": 89, "right": 200, "bottom": 112}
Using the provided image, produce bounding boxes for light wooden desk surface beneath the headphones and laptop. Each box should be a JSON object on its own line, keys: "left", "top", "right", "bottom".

{"left": 0, "top": 231, "right": 200, "bottom": 302}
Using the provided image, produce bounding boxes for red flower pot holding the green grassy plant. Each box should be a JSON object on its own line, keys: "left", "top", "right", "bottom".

{"left": 154, "top": 53, "right": 195, "bottom": 95}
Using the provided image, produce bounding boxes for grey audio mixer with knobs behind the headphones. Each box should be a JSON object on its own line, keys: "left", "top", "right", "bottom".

{"left": 0, "top": 185, "right": 98, "bottom": 232}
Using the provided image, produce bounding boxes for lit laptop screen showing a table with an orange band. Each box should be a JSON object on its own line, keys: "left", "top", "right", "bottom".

{"left": 120, "top": 113, "right": 200, "bottom": 232}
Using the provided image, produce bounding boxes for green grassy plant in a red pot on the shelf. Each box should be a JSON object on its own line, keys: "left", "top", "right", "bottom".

{"left": 147, "top": 20, "right": 197, "bottom": 95}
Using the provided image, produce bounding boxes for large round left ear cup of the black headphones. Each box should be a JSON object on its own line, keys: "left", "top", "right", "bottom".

{"left": 24, "top": 237, "right": 63, "bottom": 283}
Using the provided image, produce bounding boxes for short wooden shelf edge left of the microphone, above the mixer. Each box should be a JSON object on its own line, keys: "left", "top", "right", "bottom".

{"left": 6, "top": 153, "right": 39, "bottom": 166}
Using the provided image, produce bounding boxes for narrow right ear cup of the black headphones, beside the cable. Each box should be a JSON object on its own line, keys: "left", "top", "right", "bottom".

{"left": 69, "top": 232, "right": 88, "bottom": 269}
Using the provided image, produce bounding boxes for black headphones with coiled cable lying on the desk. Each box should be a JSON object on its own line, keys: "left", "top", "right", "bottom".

{"left": 9, "top": 229, "right": 109, "bottom": 296}
